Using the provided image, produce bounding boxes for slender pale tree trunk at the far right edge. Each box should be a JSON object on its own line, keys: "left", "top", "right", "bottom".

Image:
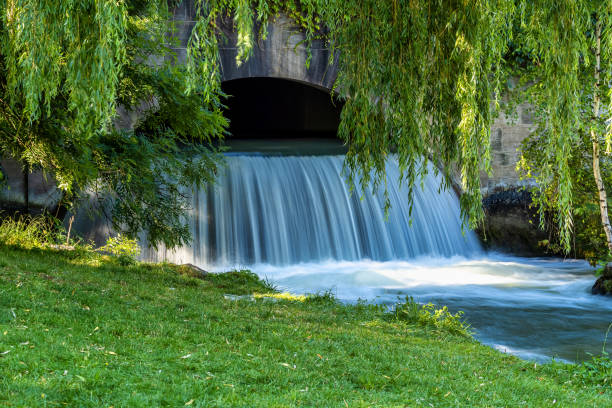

{"left": 591, "top": 21, "right": 612, "bottom": 254}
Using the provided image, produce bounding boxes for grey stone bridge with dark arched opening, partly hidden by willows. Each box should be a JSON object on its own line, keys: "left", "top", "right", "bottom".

{"left": 0, "top": 0, "right": 532, "bottom": 214}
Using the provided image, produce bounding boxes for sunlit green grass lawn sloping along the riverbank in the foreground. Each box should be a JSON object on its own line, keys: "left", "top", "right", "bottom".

{"left": 0, "top": 246, "right": 612, "bottom": 407}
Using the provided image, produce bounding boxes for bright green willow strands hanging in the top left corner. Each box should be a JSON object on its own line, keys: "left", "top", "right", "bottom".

{"left": 1, "top": 0, "right": 127, "bottom": 137}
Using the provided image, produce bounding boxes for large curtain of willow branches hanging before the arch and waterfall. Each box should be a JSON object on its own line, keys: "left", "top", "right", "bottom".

{"left": 182, "top": 0, "right": 515, "bottom": 230}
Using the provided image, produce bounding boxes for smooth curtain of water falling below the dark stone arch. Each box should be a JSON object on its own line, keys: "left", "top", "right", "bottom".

{"left": 145, "top": 155, "right": 480, "bottom": 269}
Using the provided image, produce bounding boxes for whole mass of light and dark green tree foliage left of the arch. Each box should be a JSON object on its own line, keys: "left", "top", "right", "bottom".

{"left": 0, "top": 0, "right": 227, "bottom": 246}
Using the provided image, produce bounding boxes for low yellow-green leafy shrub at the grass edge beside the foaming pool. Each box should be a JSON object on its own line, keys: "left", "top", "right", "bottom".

{"left": 393, "top": 296, "right": 472, "bottom": 337}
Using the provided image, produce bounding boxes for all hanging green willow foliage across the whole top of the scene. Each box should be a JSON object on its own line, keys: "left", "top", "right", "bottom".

{"left": 0, "top": 0, "right": 612, "bottom": 249}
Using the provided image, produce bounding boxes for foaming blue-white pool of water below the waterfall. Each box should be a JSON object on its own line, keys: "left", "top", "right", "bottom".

{"left": 247, "top": 254, "right": 612, "bottom": 361}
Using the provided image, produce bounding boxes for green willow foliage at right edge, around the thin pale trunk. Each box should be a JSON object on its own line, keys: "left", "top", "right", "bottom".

{"left": 514, "top": 1, "right": 612, "bottom": 258}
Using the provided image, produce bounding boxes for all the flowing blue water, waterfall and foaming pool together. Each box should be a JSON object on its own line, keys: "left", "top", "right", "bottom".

{"left": 145, "top": 154, "right": 612, "bottom": 361}
